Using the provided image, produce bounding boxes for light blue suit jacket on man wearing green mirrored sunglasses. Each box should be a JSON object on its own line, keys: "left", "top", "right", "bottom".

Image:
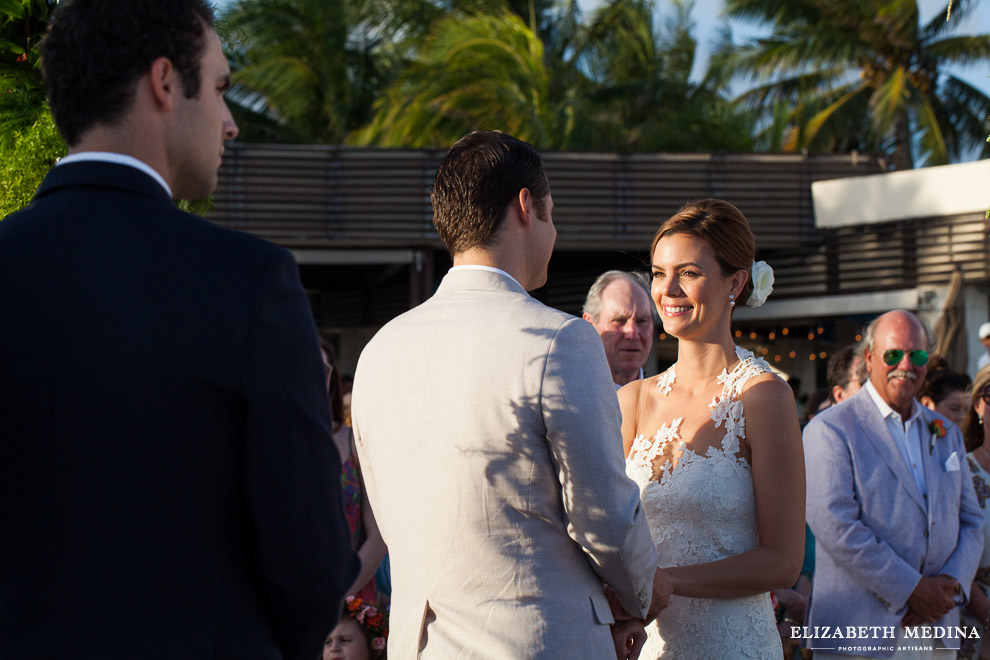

{"left": 804, "top": 388, "right": 983, "bottom": 658}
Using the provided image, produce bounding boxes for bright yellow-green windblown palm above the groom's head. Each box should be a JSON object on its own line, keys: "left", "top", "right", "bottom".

{"left": 354, "top": 9, "right": 576, "bottom": 149}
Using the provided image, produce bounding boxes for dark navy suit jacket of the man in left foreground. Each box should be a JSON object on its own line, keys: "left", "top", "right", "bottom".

{"left": 0, "top": 162, "right": 358, "bottom": 660}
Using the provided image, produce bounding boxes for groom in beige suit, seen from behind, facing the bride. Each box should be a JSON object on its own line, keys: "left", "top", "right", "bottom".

{"left": 352, "top": 131, "right": 670, "bottom": 660}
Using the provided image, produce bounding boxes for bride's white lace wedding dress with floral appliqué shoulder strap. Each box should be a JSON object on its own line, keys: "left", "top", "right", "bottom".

{"left": 626, "top": 347, "right": 783, "bottom": 660}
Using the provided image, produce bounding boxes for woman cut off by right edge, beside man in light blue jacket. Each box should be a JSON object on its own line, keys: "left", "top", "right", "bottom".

{"left": 959, "top": 367, "right": 990, "bottom": 660}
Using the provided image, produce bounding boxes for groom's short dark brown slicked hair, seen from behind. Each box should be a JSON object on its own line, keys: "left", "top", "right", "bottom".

{"left": 430, "top": 131, "right": 550, "bottom": 255}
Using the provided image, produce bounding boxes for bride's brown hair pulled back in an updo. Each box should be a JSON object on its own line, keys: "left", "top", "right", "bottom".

{"left": 650, "top": 198, "right": 756, "bottom": 305}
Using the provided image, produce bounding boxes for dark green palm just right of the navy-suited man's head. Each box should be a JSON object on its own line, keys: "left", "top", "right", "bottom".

{"left": 220, "top": 0, "right": 400, "bottom": 144}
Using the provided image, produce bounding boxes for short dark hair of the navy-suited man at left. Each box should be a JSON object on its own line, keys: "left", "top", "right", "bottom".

{"left": 40, "top": 0, "right": 213, "bottom": 146}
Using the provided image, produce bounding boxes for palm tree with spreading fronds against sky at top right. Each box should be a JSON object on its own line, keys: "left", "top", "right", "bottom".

{"left": 726, "top": 0, "right": 990, "bottom": 169}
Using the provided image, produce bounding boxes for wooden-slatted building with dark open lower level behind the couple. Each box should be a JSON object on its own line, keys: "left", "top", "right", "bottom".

{"left": 209, "top": 144, "right": 990, "bottom": 389}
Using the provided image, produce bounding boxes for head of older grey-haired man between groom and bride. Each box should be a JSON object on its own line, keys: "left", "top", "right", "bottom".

{"left": 581, "top": 270, "right": 653, "bottom": 389}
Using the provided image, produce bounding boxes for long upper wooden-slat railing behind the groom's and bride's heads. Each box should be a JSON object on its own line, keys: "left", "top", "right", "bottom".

{"left": 211, "top": 144, "right": 879, "bottom": 250}
